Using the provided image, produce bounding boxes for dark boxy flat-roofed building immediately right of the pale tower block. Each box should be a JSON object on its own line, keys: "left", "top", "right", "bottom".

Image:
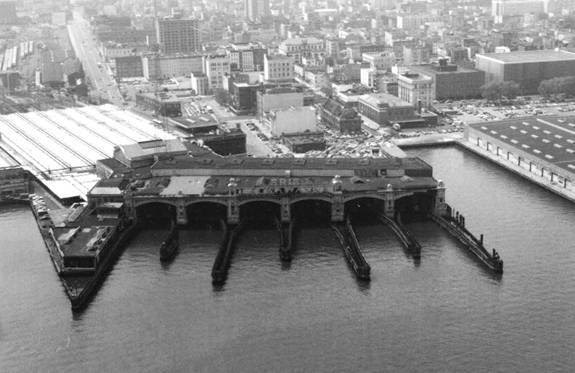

{"left": 411, "top": 59, "right": 485, "bottom": 100}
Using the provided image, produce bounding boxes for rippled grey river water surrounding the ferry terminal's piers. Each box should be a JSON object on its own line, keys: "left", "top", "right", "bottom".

{"left": 0, "top": 148, "right": 575, "bottom": 372}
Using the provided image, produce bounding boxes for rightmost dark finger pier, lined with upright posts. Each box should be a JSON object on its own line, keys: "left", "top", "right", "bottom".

{"left": 431, "top": 207, "right": 503, "bottom": 274}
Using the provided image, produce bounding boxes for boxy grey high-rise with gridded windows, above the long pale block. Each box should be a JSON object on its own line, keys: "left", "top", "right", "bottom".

{"left": 156, "top": 19, "right": 202, "bottom": 54}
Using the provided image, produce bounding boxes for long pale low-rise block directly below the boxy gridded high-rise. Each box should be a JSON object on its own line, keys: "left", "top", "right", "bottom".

{"left": 142, "top": 54, "right": 204, "bottom": 80}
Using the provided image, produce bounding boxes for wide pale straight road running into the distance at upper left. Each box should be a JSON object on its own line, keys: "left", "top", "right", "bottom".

{"left": 68, "top": 11, "right": 124, "bottom": 106}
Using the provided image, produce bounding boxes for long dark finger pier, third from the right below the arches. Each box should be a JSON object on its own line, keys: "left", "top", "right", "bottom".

{"left": 332, "top": 218, "right": 371, "bottom": 281}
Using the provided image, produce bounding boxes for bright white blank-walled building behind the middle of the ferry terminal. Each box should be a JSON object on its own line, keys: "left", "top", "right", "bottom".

{"left": 264, "top": 106, "right": 317, "bottom": 137}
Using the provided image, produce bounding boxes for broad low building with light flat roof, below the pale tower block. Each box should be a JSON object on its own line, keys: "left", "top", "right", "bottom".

{"left": 357, "top": 93, "right": 418, "bottom": 126}
